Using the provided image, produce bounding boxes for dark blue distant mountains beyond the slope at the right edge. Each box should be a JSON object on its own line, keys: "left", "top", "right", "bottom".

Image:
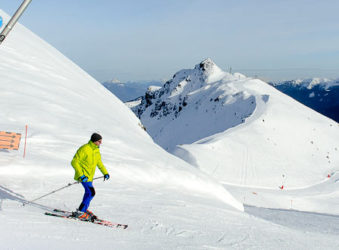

{"left": 270, "top": 78, "right": 339, "bottom": 122}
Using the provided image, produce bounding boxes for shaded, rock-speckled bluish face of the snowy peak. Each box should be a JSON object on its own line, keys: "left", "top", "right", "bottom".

{"left": 130, "top": 59, "right": 256, "bottom": 151}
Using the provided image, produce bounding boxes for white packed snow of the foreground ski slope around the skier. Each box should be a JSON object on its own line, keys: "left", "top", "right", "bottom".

{"left": 0, "top": 10, "right": 339, "bottom": 249}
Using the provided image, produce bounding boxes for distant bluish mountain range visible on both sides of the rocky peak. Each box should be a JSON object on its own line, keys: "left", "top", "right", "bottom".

{"left": 102, "top": 78, "right": 339, "bottom": 122}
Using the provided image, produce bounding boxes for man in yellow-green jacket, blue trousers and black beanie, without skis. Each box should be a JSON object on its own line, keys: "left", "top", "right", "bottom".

{"left": 71, "top": 133, "right": 110, "bottom": 220}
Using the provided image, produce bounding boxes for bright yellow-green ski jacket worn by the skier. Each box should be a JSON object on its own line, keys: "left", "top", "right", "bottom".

{"left": 71, "top": 141, "right": 108, "bottom": 182}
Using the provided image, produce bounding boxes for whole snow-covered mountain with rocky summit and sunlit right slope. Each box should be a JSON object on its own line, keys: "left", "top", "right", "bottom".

{"left": 134, "top": 59, "right": 339, "bottom": 188}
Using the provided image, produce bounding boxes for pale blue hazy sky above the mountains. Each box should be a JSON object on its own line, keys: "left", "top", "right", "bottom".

{"left": 0, "top": 0, "right": 339, "bottom": 81}
